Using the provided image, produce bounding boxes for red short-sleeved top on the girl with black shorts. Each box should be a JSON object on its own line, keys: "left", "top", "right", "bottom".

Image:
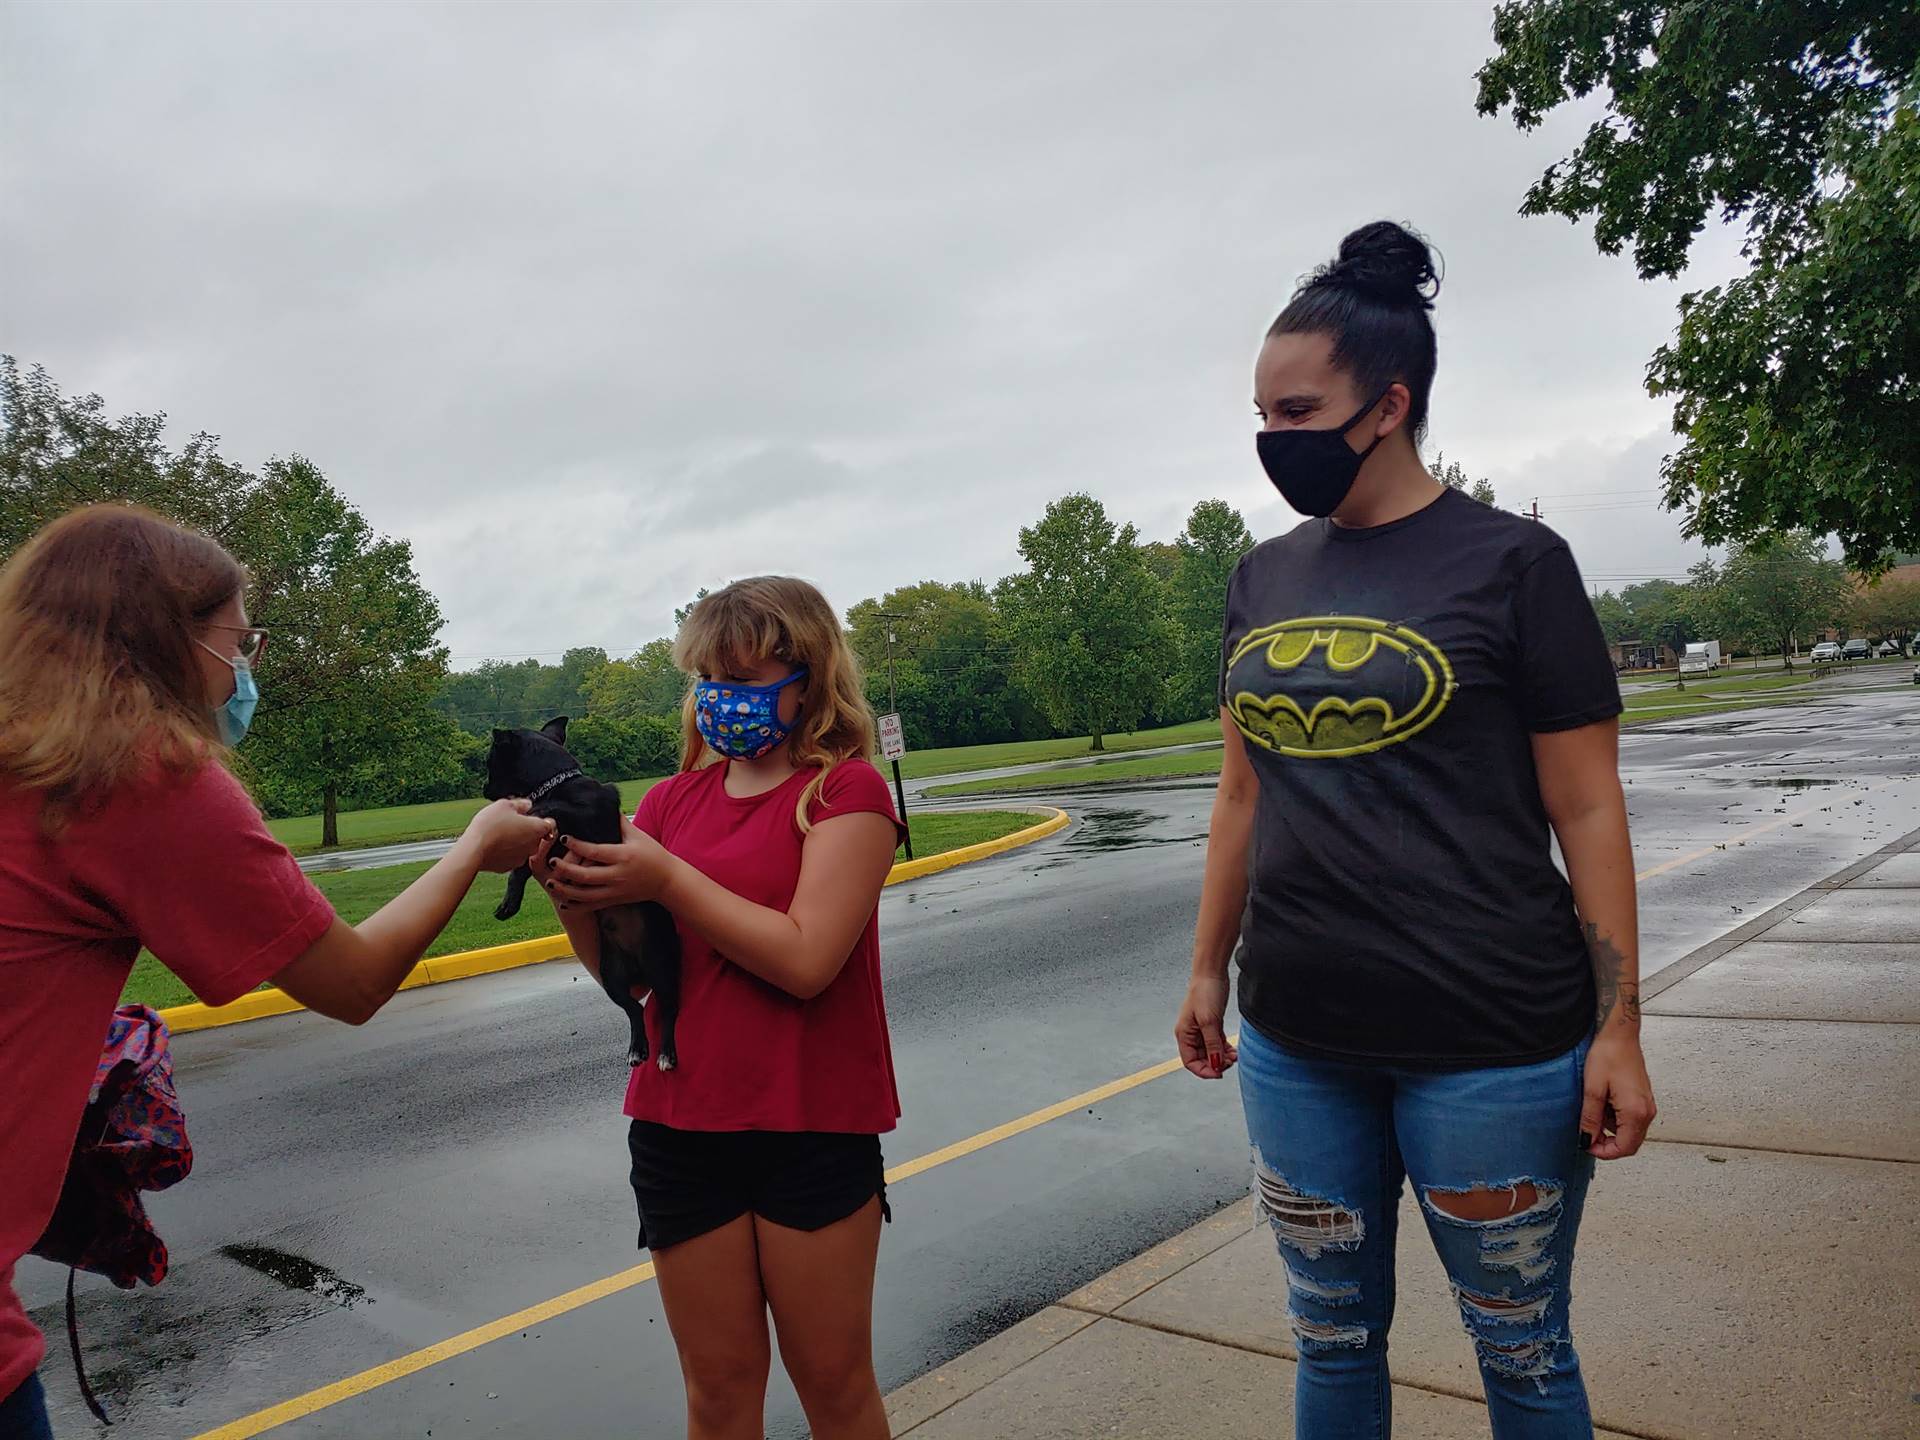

{"left": 626, "top": 760, "right": 900, "bottom": 1135}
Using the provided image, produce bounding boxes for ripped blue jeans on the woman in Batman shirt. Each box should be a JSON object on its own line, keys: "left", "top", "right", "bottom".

{"left": 1240, "top": 1025, "right": 1594, "bottom": 1440}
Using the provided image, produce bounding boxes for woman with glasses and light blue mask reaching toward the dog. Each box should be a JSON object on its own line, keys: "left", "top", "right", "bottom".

{"left": 0, "top": 505, "right": 547, "bottom": 1440}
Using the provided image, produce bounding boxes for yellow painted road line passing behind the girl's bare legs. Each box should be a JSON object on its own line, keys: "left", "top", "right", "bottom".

{"left": 194, "top": 1035, "right": 1190, "bottom": 1440}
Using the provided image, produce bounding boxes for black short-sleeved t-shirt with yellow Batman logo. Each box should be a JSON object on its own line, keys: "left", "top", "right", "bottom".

{"left": 1221, "top": 490, "right": 1622, "bottom": 1068}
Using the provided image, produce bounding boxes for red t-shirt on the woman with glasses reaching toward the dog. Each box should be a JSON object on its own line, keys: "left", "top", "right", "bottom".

{"left": 0, "top": 764, "right": 334, "bottom": 1398}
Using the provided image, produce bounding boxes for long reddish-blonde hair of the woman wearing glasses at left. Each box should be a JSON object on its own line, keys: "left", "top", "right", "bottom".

{"left": 0, "top": 505, "right": 246, "bottom": 833}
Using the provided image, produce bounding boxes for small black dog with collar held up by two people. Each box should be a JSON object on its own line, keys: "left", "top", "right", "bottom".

{"left": 480, "top": 714, "right": 680, "bottom": 1069}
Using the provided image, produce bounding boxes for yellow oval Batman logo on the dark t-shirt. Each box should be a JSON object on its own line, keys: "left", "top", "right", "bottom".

{"left": 1227, "top": 614, "right": 1455, "bottom": 760}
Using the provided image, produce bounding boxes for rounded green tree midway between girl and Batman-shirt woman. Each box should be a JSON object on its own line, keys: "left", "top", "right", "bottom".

{"left": 1000, "top": 495, "right": 1175, "bottom": 751}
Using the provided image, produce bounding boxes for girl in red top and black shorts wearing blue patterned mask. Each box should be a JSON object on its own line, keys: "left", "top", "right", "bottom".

{"left": 536, "top": 578, "right": 902, "bottom": 1440}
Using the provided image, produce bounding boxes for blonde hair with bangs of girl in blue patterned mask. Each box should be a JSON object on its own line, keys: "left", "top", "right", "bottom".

{"left": 674, "top": 576, "right": 874, "bottom": 835}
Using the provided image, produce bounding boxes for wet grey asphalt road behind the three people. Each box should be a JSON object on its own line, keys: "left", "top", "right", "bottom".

{"left": 19, "top": 678, "right": 1920, "bottom": 1438}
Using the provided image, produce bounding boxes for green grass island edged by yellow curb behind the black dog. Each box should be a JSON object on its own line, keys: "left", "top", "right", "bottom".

{"left": 121, "top": 814, "right": 1041, "bottom": 1010}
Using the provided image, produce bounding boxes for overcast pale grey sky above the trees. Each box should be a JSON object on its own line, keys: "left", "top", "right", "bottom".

{"left": 0, "top": 0, "right": 1734, "bottom": 664}
